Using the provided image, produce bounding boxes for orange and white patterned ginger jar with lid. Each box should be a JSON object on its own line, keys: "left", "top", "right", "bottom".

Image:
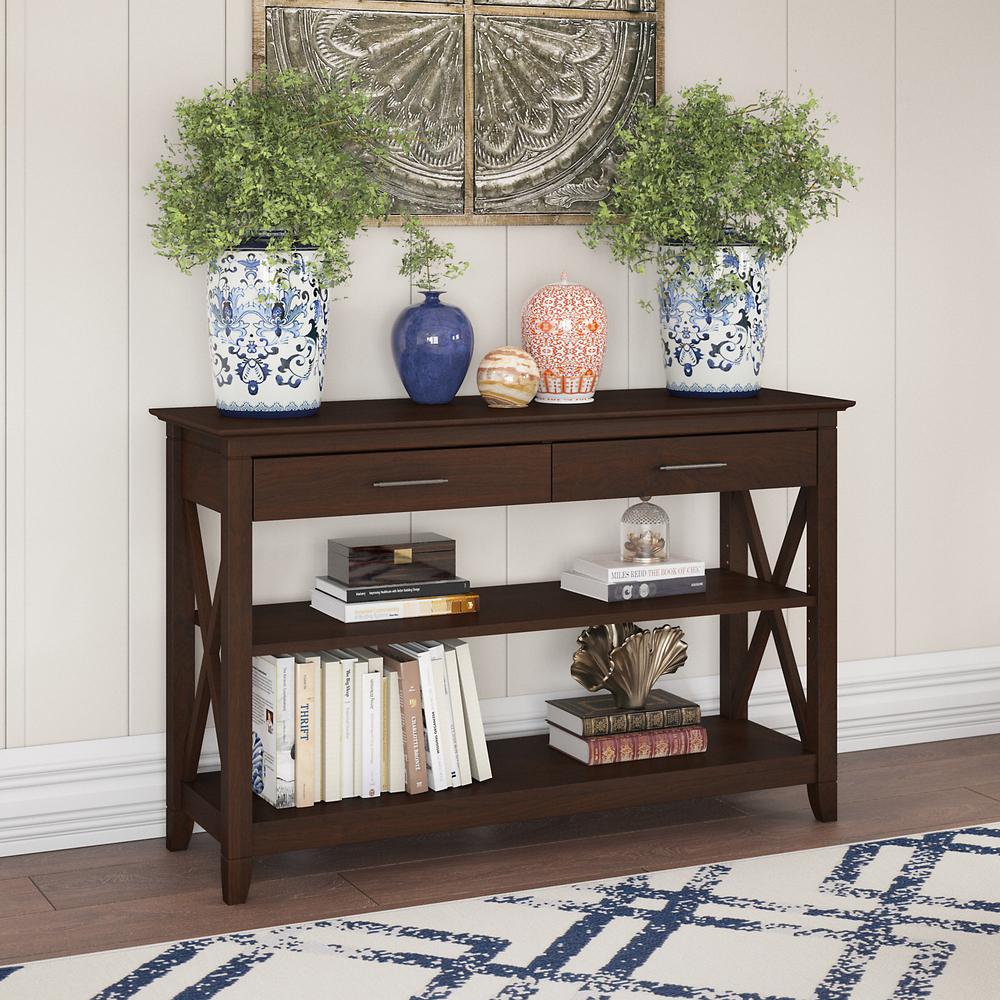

{"left": 521, "top": 274, "right": 608, "bottom": 403}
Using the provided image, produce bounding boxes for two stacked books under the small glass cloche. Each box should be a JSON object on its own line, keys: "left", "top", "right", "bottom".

{"left": 561, "top": 555, "right": 705, "bottom": 602}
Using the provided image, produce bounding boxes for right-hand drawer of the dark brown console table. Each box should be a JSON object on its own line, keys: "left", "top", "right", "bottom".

{"left": 552, "top": 431, "right": 816, "bottom": 500}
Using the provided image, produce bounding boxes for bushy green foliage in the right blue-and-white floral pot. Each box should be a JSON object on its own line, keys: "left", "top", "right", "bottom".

{"left": 581, "top": 83, "right": 858, "bottom": 295}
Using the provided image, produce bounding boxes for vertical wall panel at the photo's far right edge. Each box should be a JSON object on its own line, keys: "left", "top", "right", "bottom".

{"left": 895, "top": 0, "right": 1000, "bottom": 655}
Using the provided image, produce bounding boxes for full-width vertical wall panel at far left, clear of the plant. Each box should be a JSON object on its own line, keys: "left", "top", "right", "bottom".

{"left": 11, "top": 0, "right": 128, "bottom": 744}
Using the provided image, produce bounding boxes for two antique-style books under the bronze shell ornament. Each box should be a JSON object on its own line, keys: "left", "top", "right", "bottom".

{"left": 545, "top": 690, "right": 708, "bottom": 765}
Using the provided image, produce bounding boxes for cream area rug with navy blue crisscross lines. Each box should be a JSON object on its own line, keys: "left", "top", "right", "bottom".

{"left": 0, "top": 826, "right": 1000, "bottom": 1000}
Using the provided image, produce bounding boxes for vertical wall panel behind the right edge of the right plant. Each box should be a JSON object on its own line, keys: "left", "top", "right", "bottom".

{"left": 788, "top": 0, "right": 900, "bottom": 660}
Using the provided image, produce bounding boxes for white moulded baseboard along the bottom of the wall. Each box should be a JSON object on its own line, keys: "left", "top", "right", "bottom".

{"left": 0, "top": 646, "right": 1000, "bottom": 857}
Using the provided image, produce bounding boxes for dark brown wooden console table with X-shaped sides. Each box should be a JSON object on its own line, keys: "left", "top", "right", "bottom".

{"left": 151, "top": 389, "right": 853, "bottom": 903}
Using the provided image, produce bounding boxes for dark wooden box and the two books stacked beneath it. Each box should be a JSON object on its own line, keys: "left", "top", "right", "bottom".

{"left": 312, "top": 532, "right": 479, "bottom": 622}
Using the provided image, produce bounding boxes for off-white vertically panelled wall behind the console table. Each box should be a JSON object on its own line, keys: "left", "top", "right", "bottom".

{"left": 0, "top": 0, "right": 1000, "bottom": 746}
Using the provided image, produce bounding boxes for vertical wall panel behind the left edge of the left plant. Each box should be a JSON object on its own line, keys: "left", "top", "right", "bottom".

{"left": 128, "top": 0, "right": 227, "bottom": 733}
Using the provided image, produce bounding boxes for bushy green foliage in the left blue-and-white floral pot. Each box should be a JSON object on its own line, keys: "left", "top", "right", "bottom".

{"left": 145, "top": 71, "right": 397, "bottom": 286}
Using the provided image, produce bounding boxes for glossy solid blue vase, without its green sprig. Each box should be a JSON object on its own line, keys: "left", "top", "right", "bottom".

{"left": 392, "top": 292, "right": 474, "bottom": 405}
